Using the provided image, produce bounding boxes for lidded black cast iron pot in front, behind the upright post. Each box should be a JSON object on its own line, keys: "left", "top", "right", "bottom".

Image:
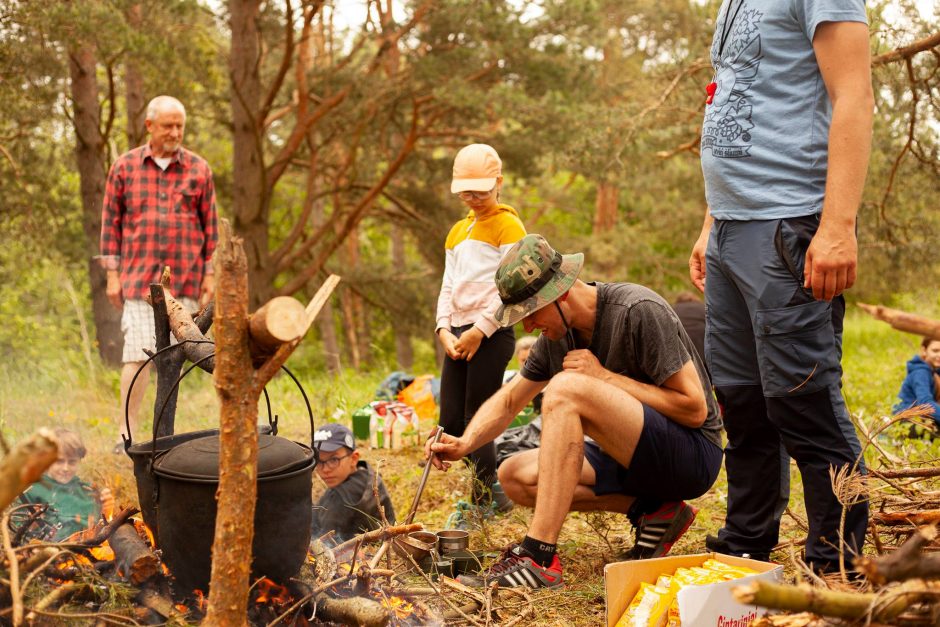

{"left": 153, "top": 435, "right": 316, "bottom": 591}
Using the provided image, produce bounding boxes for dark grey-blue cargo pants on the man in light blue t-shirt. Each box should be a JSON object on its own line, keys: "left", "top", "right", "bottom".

{"left": 705, "top": 215, "right": 868, "bottom": 570}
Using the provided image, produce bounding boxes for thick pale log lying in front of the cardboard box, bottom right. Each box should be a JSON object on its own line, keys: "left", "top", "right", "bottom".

{"left": 731, "top": 580, "right": 935, "bottom": 621}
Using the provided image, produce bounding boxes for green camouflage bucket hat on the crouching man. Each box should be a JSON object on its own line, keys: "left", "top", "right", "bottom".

{"left": 496, "top": 234, "right": 584, "bottom": 327}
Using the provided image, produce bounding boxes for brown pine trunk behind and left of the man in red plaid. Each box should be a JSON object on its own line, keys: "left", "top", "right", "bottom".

{"left": 69, "top": 44, "right": 124, "bottom": 365}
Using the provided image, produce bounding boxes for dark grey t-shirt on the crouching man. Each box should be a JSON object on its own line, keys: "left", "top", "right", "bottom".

{"left": 521, "top": 283, "right": 721, "bottom": 446}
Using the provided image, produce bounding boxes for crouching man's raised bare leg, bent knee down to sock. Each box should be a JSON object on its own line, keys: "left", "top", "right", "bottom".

{"left": 520, "top": 372, "right": 643, "bottom": 544}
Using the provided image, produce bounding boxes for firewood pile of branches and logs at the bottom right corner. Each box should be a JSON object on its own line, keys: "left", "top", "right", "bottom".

{"left": 734, "top": 407, "right": 940, "bottom": 627}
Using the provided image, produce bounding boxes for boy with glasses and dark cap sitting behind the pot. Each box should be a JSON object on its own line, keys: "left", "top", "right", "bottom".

{"left": 312, "top": 423, "right": 395, "bottom": 542}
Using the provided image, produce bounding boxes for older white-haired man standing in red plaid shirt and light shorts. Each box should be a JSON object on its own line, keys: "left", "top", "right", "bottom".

{"left": 101, "top": 96, "right": 216, "bottom": 452}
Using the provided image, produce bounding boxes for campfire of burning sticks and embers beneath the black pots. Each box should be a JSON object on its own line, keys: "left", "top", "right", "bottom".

{"left": 0, "top": 505, "right": 533, "bottom": 627}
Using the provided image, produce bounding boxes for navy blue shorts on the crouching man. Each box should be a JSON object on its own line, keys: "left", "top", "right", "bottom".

{"left": 584, "top": 405, "right": 722, "bottom": 501}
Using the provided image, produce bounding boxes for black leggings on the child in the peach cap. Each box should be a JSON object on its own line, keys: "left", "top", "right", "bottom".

{"left": 440, "top": 325, "right": 516, "bottom": 503}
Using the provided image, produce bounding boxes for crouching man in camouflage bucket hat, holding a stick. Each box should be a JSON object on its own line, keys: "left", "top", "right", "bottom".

{"left": 425, "top": 235, "right": 722, "bottom": 588}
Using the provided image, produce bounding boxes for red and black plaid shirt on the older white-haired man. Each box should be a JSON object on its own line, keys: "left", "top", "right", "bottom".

{"left": 101, "top": 143, "right": 216, "bottom": 299}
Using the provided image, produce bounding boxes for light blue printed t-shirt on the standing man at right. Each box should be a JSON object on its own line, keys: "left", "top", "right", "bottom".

{"left": 701, "top": 0, "right": 867, "bottom": 220}
